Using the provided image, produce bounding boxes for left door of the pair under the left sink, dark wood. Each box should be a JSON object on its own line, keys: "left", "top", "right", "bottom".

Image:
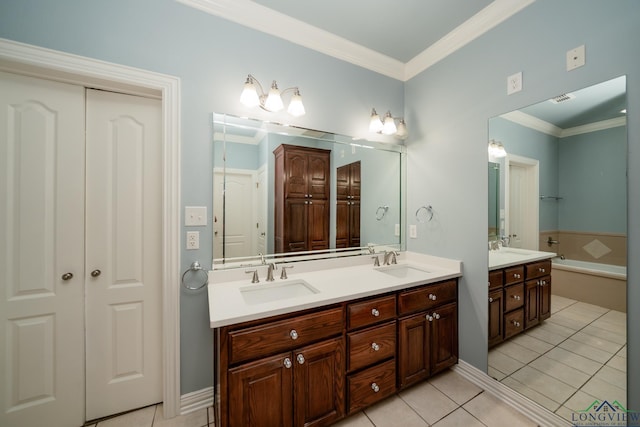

{"left": 228, "top": 353, "right": 293, "bottom": 427}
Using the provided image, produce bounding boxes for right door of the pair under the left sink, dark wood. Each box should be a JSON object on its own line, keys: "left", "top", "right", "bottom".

{"left": 296, "top": 338, "right": 345, "bottom": 427}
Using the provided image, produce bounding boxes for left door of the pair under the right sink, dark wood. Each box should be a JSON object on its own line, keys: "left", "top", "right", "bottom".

{"left": 398, "top": 313, "right": 431, "bottom": 387}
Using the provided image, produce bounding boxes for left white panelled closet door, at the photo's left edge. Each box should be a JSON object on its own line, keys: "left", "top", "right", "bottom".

{"left": 0, "top": 73, "right": 85, "bottom": 427}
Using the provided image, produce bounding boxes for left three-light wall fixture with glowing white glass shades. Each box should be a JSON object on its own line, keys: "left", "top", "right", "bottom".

{"left": 240, "top": 74, "right": 306, "bottom": 117}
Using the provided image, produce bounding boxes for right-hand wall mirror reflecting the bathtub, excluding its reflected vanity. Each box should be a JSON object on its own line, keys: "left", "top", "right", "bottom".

{"left": 488, "top": 76, "right": 627, "bottom": 420}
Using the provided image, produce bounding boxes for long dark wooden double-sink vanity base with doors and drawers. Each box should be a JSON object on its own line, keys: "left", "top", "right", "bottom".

{"left": 214, "top": 279, "right": 458, "bottom": 427}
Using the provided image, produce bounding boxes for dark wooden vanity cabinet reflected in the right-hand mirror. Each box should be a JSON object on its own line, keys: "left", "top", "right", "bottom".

{"left": 488, "top": 260, "right": 551, "bottom": 347}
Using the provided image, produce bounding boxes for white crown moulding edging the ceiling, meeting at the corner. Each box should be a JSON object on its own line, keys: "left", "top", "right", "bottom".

{"left": 176, "top": 0, "right": 535, "bottom": 81}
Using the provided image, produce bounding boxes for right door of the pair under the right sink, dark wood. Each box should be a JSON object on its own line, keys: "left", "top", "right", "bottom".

{"left": 431, "top": 303, "right": 458, "bottom": 375}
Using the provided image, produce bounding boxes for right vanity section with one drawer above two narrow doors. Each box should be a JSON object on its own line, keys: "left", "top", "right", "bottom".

{"left": 398, "top": 281, "right": 458, "bottom": 388}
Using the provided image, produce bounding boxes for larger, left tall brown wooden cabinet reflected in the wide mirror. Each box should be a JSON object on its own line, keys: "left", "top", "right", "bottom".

{"left": 273, "top": 144, "right": 331, "bottom": 253}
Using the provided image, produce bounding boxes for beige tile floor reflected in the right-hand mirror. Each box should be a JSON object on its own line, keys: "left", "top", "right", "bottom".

{"left": 489, "top": 295, "right": 627, "bottom": 420}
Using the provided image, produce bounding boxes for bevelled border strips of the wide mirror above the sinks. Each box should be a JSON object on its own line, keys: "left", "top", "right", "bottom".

{"left": 211, "top": 112, "right": 407, "bottom": 270}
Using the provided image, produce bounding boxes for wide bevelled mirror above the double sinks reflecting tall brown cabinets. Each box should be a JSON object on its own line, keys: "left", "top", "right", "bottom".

{"left": 213, "top": 113, "right": 405, "bottom": 268}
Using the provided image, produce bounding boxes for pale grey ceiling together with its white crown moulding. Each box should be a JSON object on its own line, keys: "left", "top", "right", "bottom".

{"left": 177, "top": 0, "right": 534, "bottom": 81}
